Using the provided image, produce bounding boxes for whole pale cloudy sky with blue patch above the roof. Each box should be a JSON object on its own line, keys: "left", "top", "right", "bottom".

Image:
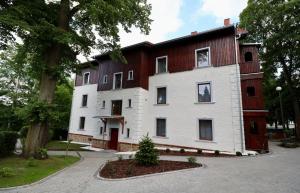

{"left": 80, "top": 0, "right": 247, "bottom": 60}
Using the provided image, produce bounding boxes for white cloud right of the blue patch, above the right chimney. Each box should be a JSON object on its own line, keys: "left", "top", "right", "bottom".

{"left": 198, "top": 0, "right": 247, "bottom": 23}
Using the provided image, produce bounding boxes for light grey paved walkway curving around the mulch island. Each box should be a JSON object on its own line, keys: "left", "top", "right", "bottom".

{"left": 1, "top": 144, "right": 300, "bottom": 193}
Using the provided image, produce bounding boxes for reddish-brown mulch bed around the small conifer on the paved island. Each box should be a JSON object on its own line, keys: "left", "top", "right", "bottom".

{"left": 100, "top": 159, "right": 202, "bottom": 179}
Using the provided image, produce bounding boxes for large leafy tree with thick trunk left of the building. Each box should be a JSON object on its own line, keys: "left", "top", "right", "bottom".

{"left": 0, "top": 0, "right": 151, "bottom": 157}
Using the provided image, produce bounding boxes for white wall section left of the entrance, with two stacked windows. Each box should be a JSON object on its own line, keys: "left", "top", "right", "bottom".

{"left": 69, "top": 84, "right": 100, "bottom": 136}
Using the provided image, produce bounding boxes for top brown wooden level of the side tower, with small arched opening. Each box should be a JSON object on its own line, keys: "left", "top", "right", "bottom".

{"left": 240, "top": 45, "right": 260, "bottom": 74}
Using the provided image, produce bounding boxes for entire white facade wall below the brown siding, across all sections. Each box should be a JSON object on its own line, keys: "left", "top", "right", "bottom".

{"left": 70, "top": 65, "right": 244, "bottom": 152}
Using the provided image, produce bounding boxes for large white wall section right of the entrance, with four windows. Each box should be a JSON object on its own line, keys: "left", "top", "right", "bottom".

{"left": 143, "top": 65, "right": 242, "bottom": 152}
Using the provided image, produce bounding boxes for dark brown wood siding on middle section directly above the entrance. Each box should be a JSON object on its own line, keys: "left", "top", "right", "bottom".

{"left": 98, "top": 51, "right": 148, "bottom": 91}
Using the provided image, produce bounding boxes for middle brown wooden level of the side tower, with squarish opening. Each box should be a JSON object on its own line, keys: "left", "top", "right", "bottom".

{"left": 241, "top": 79, "right": 264, "bottom": 110}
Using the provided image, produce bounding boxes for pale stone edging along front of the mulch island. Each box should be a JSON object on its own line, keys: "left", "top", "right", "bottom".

{"left": 94, "top": 163, "right": 207, "bottom": 181}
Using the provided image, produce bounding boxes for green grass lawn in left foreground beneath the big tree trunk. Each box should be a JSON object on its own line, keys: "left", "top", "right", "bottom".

{"left": 0, "top": 156, "right": 80, "bottom": 188}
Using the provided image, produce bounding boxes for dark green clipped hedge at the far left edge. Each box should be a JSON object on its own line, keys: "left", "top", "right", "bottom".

{"left": 0, "top": 131, "right": 18, "bottom": 157}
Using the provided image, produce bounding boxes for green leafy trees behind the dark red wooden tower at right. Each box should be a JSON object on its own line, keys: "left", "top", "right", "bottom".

{"left": 240, "top": 0, "right": 300, "bottom": 134}
